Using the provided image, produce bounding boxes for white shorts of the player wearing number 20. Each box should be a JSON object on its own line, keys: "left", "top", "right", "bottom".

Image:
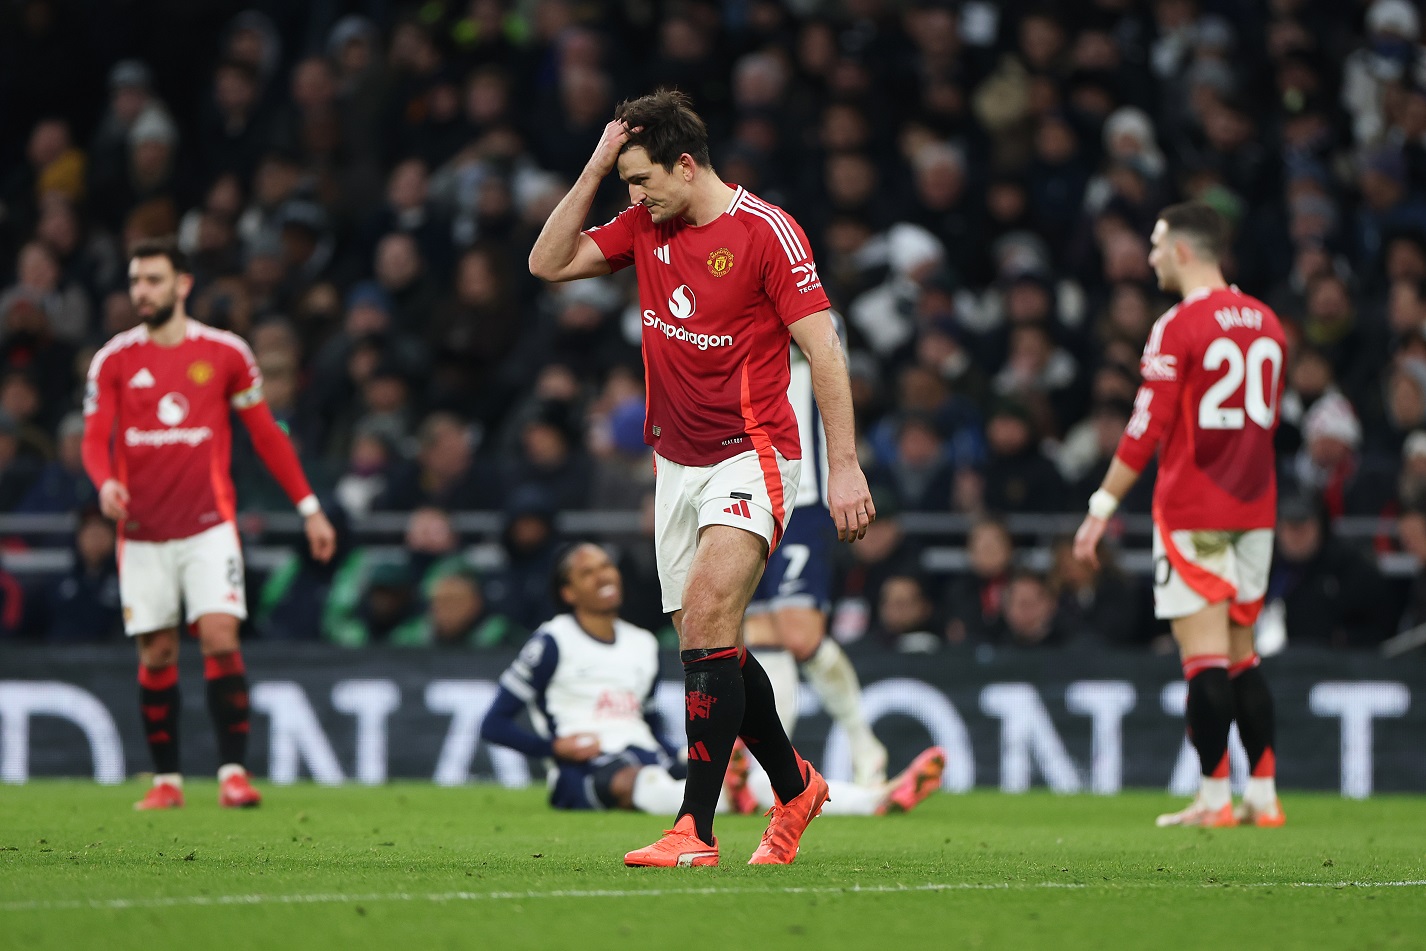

{"left": 1154, "top": 523, "right": 1272, "bottom": 627}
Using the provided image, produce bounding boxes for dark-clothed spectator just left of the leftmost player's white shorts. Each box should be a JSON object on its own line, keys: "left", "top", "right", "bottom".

{"left": 27, "top": 508, "right": 124, "bottom": 644}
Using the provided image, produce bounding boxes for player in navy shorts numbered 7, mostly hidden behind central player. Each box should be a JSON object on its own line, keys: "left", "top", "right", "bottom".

{"left": 743, "top": 337, "right": 887, "bottom": 787}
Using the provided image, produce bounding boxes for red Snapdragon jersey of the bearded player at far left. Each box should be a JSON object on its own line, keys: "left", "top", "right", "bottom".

{"left": 84, "top": 318, "right": 262, "bottom": 542}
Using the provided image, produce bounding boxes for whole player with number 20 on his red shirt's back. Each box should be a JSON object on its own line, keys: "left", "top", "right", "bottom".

{"left": 1075, "top": 202, "right": 1286, "bottom": 826}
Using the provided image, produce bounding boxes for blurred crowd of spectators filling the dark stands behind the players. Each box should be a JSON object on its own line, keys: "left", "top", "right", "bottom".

{"left": 0, "top": 0, "right": 1426, "bottom": 652}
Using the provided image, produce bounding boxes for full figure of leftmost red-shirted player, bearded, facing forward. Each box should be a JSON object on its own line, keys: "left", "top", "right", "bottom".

{"left": 84, "top": 241, "right": 337, "bottom": 808}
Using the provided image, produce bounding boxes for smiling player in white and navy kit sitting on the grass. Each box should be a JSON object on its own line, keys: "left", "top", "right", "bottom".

{"left": 481, "top": 543, "right": 945, "bottom": 816}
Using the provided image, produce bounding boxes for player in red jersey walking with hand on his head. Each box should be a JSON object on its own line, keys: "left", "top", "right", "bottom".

{"left": 529, "top": 91, "right": 876, "bottom": 865}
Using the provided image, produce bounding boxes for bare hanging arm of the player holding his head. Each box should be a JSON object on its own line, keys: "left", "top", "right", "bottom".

{"left": 790, "top": 311, "right": 877, "bottom": 542}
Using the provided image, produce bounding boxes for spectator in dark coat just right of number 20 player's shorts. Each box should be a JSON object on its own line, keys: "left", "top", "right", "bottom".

{"left": 1266, "top": 493, "right": 1392, "bottom": 649}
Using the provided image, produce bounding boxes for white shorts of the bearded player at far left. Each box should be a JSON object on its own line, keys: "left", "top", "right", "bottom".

{"left": 118, "top": 522, "right": 248, "bottom": 637}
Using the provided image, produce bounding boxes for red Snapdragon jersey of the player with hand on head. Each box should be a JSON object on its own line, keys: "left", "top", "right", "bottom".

{"left": 585, "top": 185, "right": 831, "bottom": 466}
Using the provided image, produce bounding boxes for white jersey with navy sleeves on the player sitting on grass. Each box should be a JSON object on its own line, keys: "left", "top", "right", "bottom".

{"left": 501, "top": 615, "right": 660, "bottom": 753}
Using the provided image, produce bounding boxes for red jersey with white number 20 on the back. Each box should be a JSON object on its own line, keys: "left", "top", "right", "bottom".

{"left": 1117, "top": 287, "right": 1288, "bottom": 532}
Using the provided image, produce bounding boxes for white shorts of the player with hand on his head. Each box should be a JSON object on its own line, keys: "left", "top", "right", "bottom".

{"left": 653, "top": 449, "right": 801, "bottom": 613}
